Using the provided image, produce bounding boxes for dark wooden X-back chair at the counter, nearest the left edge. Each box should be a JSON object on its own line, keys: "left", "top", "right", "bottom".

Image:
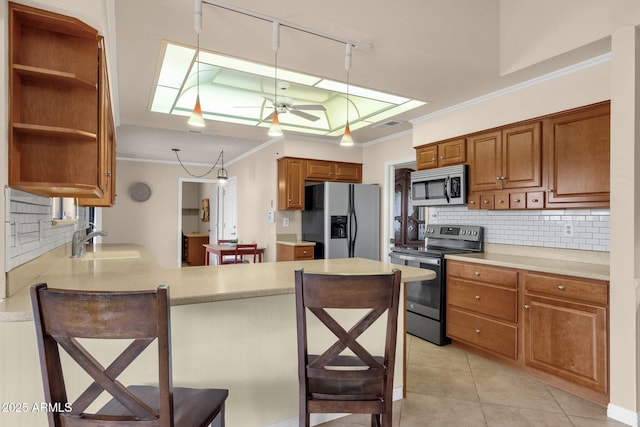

{"left": 30, "top": 283, "right": 229, "bottom": 427}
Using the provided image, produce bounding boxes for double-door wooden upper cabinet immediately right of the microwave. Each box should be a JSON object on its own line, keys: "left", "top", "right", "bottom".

{"left": 468, "top": 122, "right": 542, "bottom": 193}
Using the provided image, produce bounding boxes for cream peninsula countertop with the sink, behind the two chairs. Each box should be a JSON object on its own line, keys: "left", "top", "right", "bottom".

{"left": 0, "top": 244, "right": 434, "bottom": 322}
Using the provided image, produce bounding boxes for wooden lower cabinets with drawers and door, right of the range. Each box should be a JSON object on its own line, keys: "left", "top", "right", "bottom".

{"left": 446, "top": 260, "right": 609, "bottom": 405}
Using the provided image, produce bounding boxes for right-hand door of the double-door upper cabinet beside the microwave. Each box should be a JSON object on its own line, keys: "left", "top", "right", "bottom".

{"left": 500, "top": 122, "right": 542, "bottom": 188}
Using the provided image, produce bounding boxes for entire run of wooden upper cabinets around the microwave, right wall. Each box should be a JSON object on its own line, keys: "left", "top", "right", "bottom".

{"left": 416, "top": 101, "right": 610, "bottom": 209}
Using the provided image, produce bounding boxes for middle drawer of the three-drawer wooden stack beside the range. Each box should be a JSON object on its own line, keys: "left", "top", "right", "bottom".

{"left": 447, "top": 278, "right": 518, "bottom": 323}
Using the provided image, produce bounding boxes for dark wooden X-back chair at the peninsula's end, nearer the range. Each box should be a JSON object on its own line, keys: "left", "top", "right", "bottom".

{"left": 295, "top": 270, "right": 400, "bottom": 427}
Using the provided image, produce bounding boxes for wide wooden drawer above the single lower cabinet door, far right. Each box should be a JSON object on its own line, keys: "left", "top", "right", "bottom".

{"left": 524, "top": 272, "right": 609, "bottom": 305}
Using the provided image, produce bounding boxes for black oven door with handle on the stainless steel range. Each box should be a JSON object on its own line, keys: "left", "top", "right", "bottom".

{"left": 391, "top": 253, "right": 444, "bottom": 320}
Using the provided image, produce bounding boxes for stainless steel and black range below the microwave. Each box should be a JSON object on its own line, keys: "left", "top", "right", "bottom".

{"left": 389, "top": 224, "right": 484, "bottom": 345}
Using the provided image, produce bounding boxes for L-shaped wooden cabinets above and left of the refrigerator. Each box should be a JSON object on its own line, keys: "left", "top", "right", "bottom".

{"left": 278, "top": 157, "right": 362, "bottom": 211}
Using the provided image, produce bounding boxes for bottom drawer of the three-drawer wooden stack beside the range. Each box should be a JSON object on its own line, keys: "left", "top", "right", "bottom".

{"left": 447, "top": 308, "right": 518, "bottom": 360}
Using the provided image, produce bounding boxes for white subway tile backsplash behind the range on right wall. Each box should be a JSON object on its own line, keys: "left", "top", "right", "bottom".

{"left": 427, "top": 206, "right": 609, "bottom": 252}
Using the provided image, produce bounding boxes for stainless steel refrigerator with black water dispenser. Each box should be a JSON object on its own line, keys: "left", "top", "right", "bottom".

{"left": 302, "top": 182, "right": 380, "bottom": 260}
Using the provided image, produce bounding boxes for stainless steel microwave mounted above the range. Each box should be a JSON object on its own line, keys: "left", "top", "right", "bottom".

{"left": 411, "top": 165, "right": 467, "bottom": 206}
